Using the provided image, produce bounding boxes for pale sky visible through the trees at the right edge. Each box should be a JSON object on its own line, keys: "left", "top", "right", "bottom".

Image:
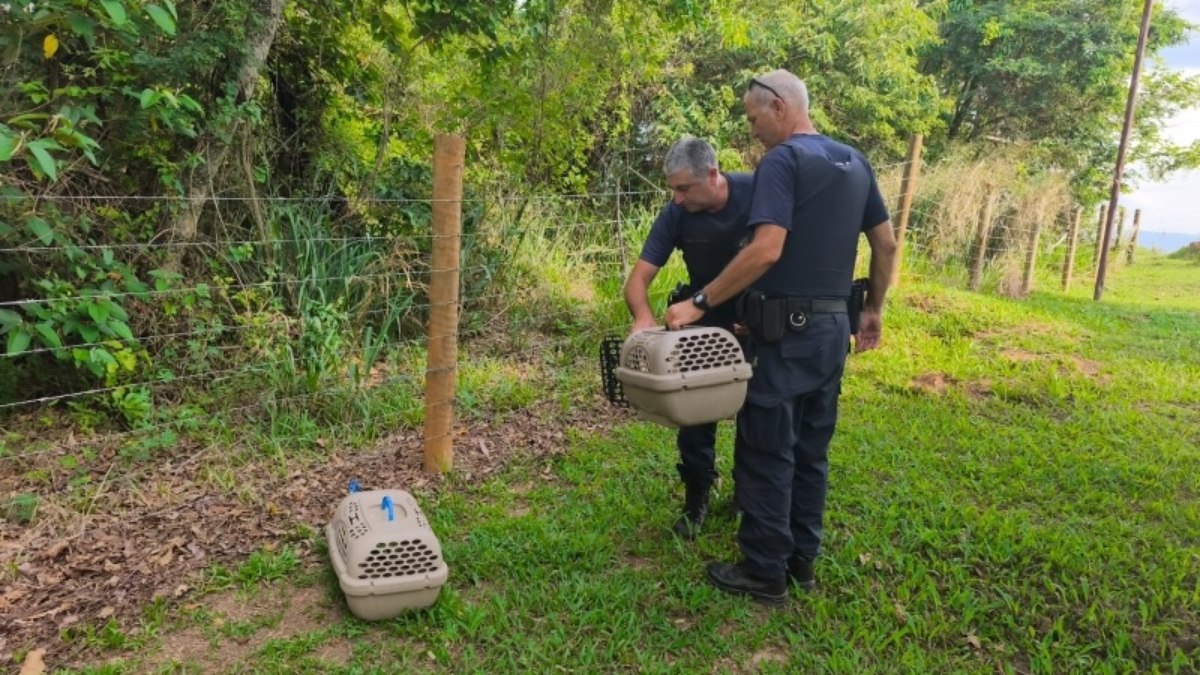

{"left": 1121, "top": 0, "right": 1200, "bottom": 235}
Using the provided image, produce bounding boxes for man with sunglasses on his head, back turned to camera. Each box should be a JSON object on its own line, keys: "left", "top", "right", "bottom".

{"left": 666, "top": 70, "right": 896, "bottom": 604}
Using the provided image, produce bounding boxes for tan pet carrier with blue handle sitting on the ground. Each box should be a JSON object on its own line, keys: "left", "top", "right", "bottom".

{"left": 325, "top": 483, "right": 450, "bottom": 621}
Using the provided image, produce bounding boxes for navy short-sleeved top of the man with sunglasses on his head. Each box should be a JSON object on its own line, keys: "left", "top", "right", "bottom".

{"left": 748, "top": 133, "right": 888, "bottom": 298}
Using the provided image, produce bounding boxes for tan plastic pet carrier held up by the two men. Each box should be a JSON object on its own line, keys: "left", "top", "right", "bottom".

{"left": 617, "top": 327, "right": 751, "bottom": 426}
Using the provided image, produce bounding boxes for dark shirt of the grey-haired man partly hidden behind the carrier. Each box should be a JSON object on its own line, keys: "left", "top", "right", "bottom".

{"left": 641, "top": 173, "right": 754, "bottom": 324}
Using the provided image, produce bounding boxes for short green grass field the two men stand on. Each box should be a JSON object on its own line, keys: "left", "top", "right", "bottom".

{"left": 58, "top": 257, "right": 1200, "bottom": 673}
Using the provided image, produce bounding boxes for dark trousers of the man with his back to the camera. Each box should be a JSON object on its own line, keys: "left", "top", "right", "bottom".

{"left": 733, "top": 313, "right": 850, "bottom": 579}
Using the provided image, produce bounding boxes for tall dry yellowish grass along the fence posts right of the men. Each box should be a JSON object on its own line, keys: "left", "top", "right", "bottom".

{"left": 880, "top": 142, "right": 1141, "bottom": 298}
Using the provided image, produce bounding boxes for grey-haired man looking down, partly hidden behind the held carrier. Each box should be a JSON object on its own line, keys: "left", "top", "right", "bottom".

{"left": 625, "top": 137, "right": 754, "bottom": 539}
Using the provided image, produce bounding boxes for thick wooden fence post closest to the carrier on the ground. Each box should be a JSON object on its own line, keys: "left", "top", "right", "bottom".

{"left": 425, "top": 135, "right": 467, "bottom": 473}
